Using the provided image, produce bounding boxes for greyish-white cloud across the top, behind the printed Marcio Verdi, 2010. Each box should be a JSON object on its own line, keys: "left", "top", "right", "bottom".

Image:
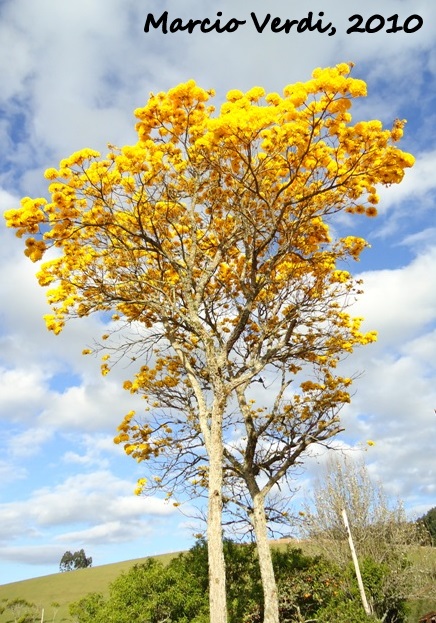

{"left": 0, "top": 0, "right": 435, "bottom": 192}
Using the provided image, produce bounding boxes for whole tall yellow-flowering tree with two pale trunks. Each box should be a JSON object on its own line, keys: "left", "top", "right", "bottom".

{"left": 6, "top": 64, "right": 413, "bottom": 623}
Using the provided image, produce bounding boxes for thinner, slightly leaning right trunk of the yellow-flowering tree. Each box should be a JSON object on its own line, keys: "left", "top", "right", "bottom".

{"left": 252, "top": 493, "right": 279, "bottom": 623}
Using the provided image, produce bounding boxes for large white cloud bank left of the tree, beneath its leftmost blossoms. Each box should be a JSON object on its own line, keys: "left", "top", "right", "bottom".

{"left": 0, "top": 228, "right": 147, "bottom": 432}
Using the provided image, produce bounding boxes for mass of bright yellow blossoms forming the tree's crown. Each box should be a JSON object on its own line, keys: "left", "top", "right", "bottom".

{"left": 5, "top": 63, "right": 414, "bottom": 472}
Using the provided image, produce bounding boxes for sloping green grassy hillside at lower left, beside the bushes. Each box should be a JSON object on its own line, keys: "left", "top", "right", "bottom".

{"left": 0, "top": 554, "right": 176, "bottom": 623}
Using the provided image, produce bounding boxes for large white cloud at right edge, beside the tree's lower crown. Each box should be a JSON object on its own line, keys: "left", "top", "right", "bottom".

{"left": 324, "top": 247, "right": 436, "bottom": 509}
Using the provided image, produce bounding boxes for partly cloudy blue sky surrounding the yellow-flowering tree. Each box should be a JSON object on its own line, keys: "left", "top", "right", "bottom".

{"left": 0, "top": 0, "right": 436, "bottom": 584}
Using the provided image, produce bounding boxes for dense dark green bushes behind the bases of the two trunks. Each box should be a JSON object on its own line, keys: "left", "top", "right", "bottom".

{"left": 70, "top": 540, "right": 416, "bottom": 623}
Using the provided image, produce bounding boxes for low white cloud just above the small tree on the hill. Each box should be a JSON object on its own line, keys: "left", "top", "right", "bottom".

{"left": 0, "top": 470, "right": 177, "bottom": 551}
